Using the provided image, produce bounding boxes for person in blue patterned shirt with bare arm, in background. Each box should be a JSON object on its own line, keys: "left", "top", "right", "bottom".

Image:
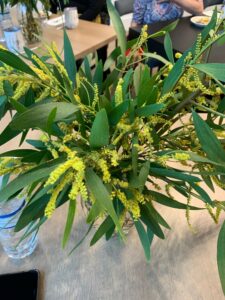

{"left": 131, "top": 0, "right": 204, "bottom": 27}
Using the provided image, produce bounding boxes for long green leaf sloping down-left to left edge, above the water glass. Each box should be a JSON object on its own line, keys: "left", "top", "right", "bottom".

{"left": 0, "top": 158, "right": 64, "bottom": 202}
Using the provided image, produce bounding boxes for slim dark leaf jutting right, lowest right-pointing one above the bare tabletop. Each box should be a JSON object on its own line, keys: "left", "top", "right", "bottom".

{"left": 149, "top": 191, "right": 203, "bottom": 210}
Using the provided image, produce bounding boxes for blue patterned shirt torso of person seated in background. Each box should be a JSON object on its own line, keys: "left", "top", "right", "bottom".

{"left": 144, "top": 0, "right": 183, "bottom": 24}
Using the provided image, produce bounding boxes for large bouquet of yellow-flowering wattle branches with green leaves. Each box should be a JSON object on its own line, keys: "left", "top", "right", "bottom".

{"left": 0, "top": 1, "right": 225, "bottom": 290}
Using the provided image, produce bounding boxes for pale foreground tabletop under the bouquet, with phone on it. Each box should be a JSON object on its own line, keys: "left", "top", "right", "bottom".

{"left": 0, "top": 116, "right": 225, "bottom": 300}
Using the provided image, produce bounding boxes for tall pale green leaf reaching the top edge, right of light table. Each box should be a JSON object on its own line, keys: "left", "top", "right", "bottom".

{"left": 107, "top": 0, "right": 126, "bottom": 59}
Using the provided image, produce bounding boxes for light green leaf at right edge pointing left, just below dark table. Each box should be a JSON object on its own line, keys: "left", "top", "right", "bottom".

{"left": 192, "top": 63, "right": 225, "bottom": 82}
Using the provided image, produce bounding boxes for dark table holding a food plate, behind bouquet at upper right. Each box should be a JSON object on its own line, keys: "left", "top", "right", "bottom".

{"left": 129, "top": 17, "right": 225, "bottom": 63}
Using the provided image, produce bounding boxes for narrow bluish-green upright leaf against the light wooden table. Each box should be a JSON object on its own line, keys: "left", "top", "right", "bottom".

{"left": 64, "top": 30, "right": 77, "bottom": 87}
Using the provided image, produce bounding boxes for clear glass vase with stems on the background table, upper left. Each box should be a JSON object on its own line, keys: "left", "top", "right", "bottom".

{"left": 17, "top": 4, "right": 42, "bottom": 44}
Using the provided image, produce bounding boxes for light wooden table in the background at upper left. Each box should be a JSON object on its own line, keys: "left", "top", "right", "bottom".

{"left": 43, "top": 20, "right": 116, "bottom": 59}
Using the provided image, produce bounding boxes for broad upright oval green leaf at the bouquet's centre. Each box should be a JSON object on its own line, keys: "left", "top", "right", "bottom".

{"left": 90, "top": 108, "right": 109, "bottom": 148}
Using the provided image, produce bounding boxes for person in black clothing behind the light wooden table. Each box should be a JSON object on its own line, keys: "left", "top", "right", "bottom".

{"left": 50, "top": 0, "right": 109, "bottom": 75}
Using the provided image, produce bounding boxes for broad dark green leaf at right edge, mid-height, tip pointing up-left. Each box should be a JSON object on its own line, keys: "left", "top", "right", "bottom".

{"left": 192, "top": 112, "right": 225, "bottom": 162}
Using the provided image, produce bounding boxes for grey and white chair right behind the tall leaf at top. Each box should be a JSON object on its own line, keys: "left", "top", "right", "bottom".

{"left": 114, "top": 0, "right": 134, "bottom": 32}
